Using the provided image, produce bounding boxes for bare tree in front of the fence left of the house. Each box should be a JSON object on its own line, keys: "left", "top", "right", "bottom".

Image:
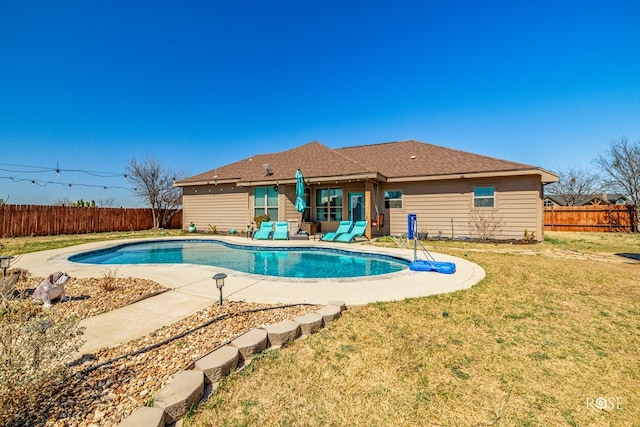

{"left": 127, "top": 157, "right": 182, "bottom": 228}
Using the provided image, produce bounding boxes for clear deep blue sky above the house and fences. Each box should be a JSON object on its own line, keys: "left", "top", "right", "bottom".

{"left": 0, "top": 0, "right": 640, "bottom": 206}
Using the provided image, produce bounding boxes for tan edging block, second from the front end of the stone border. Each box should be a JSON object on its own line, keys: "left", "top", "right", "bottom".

{"left": 153, "top": 371, "right": 204, "bottom": 424}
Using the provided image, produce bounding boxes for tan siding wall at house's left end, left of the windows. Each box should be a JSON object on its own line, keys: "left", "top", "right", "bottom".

{"left": 182, "top": 185, "right": 252, "bottom": 231}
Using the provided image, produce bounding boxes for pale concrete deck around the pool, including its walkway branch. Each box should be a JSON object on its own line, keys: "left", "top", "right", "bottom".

{"left": 12, "top": 235, "right": 485, "bottom": 353}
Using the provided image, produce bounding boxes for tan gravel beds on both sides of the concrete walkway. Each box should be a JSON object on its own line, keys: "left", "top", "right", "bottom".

{"left": 10, "top": 277, "right": 319, "bottom": 427}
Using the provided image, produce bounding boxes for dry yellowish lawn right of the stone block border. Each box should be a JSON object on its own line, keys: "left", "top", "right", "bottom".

{"left": 187, "top": 233, "right": 640, "bottom": 426}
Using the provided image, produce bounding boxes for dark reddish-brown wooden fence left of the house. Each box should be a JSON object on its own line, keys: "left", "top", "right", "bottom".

{"left": 0, "top": 205, "right": 182, "bottom": 237}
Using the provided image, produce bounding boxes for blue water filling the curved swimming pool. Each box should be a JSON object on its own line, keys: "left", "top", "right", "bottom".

{"left": 69, "top": 240, "right": 409, "bottom": 279}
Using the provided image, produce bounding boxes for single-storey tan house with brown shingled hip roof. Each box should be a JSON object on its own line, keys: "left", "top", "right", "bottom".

{"left": 175, "top": 141, "right": 558, "bottom": 240}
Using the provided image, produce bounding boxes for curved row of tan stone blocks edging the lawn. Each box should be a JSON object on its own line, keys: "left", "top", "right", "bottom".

{"left": 118, "top": 301, "right": 347, "bottom": 427}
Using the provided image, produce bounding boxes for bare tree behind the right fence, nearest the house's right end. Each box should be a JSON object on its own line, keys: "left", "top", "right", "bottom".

{"left": 545, "top": 168, "right": 601, "bottom": 206}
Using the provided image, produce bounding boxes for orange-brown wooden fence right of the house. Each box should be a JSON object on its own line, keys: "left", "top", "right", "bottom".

{"left": 544, "top": 205, "right": 638, "bottom": 233}
